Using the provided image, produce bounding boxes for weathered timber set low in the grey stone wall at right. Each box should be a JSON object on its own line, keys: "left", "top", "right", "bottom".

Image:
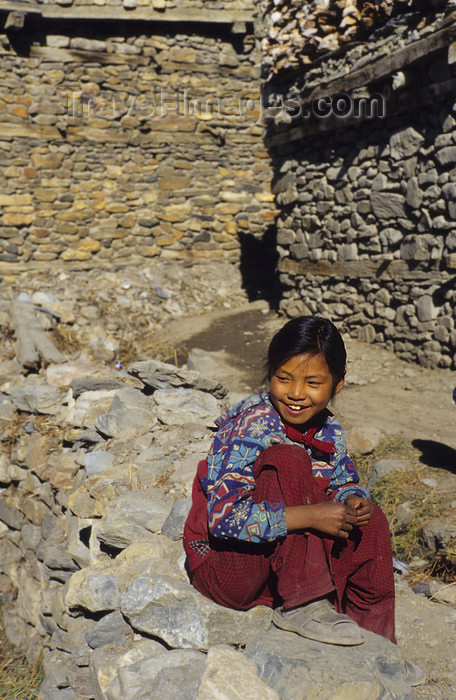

{"left": 278, "top": 258, "right": 450, "bottom": 285}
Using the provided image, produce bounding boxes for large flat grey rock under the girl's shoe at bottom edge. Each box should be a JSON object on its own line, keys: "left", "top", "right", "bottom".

{"left": 245, "top": 628, "right": 412, "bottom": 700}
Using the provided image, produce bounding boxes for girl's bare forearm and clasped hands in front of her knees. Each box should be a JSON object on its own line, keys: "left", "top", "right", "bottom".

{"left": 285, "top": 501, "right": 357, "bottom": 539}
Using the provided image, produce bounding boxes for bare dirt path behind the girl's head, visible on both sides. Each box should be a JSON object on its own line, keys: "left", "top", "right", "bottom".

{"left": 164, "top": 302, "right": 456, "bottom": 454}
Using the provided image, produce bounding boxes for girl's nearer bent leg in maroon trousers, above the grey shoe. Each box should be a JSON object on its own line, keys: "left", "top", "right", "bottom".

{"left": 193, "top": 445, "right": 334, "bottom": 610}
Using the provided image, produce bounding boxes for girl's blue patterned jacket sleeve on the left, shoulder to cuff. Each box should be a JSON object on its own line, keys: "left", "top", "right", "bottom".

{"left": 207, "top": 412, "right": 287, "bottom": 542}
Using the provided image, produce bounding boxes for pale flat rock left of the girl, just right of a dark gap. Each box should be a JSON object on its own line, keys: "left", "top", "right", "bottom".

{"left": 97, "top": 488, "right": 172, "bottom": 549}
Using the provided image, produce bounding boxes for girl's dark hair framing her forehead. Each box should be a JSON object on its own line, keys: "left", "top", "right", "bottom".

{"left": 267, "top": 316, "right": 347, "bottom": 391}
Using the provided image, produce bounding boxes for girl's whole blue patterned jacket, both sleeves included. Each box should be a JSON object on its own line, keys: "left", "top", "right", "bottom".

{"left": 207, "top": 393, "right": 369, "bottom": 542}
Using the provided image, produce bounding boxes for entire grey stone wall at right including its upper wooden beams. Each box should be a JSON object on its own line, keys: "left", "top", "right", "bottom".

{"left": 267, "top": 8, "right": 456, "bottom": 367}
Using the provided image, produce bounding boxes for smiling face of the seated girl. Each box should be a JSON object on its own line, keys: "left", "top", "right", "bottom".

{"left": 270, "top": 353, "right": 344, "bottom": 426}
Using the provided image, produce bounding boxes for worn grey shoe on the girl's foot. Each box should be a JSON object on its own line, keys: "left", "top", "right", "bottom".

{"left": 272, "top": 598, "right": 364, "bottom": 646}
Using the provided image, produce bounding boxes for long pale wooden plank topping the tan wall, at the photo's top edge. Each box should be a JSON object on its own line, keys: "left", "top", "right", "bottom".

{"left": 0, "top": 0, "right": 255, "bottom": 24}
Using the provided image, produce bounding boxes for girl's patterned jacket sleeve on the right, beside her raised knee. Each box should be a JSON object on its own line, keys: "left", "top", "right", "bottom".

{"left": 328, "top": 418, "right": 370, "bottom": 503}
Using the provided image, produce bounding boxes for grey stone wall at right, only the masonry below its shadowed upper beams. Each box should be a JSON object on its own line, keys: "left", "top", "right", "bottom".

{"left": 268, "top": 107, "right": 456, "bottom": 367}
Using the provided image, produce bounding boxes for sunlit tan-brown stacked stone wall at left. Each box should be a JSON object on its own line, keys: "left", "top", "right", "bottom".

{"left": 0, "top": 10, "right": 275, "bottom": 268}
